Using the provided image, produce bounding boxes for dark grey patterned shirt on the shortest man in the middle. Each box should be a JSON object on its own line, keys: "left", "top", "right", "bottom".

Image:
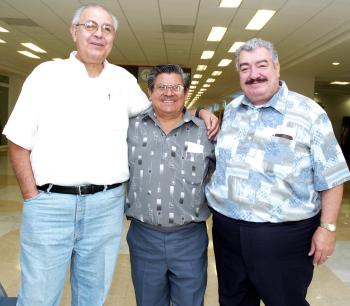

{"left": 125, "top": 110, "right": 215, "bottom": 227}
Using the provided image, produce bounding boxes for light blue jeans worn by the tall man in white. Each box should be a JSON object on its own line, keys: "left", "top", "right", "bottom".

{"left": 17, "top": 185, "right": 125, "bottom": 306}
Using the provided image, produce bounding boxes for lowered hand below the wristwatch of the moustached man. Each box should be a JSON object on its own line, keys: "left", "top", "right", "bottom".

{"left": 308, "top": 227, "right": 336, "bottom": 265}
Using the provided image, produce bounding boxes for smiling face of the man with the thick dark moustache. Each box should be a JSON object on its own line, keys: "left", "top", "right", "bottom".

{"left": 239, "top": 48, "right": 280, "bottom": 105}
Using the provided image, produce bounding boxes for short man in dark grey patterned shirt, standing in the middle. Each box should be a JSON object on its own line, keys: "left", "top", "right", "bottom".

{"left": 126, "top": 65, "right": 214, "bottom": 306}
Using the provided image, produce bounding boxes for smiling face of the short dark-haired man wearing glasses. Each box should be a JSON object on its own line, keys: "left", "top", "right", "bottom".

{"left": 149, "top": 73, "right": 186, "bottom": 118}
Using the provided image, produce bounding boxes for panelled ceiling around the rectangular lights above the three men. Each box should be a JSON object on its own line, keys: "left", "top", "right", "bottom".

{"left": 0, "top": 0, "right": 350, "bottom": 106}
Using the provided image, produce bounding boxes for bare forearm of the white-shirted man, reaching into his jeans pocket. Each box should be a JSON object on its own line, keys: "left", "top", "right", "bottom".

{"left": 9, "top": 141, "right": 38, "bottom": 199}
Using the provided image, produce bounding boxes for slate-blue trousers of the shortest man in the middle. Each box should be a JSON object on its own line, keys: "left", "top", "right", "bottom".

{"left": 127, "top": 221, "right": 208, "bottom": 306}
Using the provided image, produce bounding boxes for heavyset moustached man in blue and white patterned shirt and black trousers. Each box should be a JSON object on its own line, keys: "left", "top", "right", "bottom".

{"left": 206, "top": 38, "right": 350, "bottom": 306}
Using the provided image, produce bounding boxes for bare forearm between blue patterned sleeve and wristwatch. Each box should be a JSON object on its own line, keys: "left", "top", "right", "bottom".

{"left": 321, "top": 184, "right": 343, "bottom": 224}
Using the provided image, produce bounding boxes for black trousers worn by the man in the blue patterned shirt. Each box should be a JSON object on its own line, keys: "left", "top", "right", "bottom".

{"left": 212, "top": 210, "right": 320, "bottom": 306}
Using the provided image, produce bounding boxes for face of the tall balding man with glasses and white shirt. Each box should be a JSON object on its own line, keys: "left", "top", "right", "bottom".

{"left": 71, "top": 7, "right": 115, "bottom": 64}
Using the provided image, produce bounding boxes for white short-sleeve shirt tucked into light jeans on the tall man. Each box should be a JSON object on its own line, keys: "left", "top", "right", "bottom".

{"left": 3, "top": 52, "right": 150, "bottom": 186}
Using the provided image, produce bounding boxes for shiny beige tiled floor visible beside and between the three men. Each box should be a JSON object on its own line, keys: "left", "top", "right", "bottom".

{"left": 0, "top": 151, "right": 350, "bottom": 306}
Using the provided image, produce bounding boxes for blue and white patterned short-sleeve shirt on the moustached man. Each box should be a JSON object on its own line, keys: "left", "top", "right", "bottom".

{"left": 206, "top": 82, "right": 350, "bottom": 222}
